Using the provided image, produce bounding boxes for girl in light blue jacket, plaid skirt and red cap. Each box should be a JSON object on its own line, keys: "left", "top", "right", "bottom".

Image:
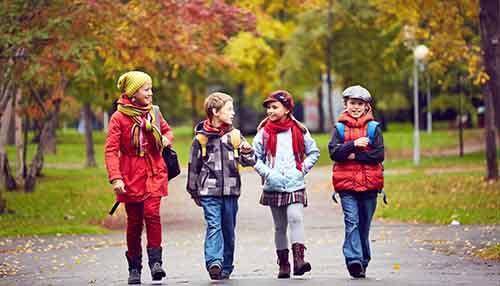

{"left": 253, "top": 90, "right": 319, "bottom": 278}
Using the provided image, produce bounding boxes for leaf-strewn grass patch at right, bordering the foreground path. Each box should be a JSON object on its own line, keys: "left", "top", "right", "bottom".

{"left": 377, "top": 171, "right": 500, "bottom": 224}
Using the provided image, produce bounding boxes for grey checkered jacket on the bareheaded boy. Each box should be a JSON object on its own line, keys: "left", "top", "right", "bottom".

{"left": 186, "top": 122, "right": 255, "bottom": 197}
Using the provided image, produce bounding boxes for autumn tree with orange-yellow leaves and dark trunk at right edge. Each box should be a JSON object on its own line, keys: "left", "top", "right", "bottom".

{"left": 370, "top": 0, "right": 500, "bottom": 177}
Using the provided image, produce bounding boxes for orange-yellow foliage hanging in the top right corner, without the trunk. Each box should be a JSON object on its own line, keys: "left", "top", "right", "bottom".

{"left": 370, "top": 0, "right": 483, "bottom": 84}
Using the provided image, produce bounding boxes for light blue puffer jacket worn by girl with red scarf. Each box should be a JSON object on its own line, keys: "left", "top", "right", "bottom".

{"left": 253, "top": 120, "right": 319, "bottom": 192}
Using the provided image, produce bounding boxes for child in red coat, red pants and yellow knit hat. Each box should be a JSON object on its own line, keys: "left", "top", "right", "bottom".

{"left": 104, "top": 71, "right": 173, "bottom": 284}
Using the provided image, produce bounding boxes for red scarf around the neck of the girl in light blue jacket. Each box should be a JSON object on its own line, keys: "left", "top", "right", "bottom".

{"left": 264, "top": 117, "right": 305, "bottom": 171}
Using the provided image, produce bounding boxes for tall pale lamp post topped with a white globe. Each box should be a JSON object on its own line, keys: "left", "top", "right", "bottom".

{"left": 413, "top": 45, "right": 429, "bottom": 165}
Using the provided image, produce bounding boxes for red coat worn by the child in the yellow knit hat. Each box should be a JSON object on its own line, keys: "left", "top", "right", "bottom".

{"left": 104, "top": 99, "right": 173, "bottom": 203}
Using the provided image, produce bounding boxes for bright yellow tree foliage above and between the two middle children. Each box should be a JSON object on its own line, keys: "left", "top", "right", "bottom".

{"left": 224, "top": 0, "right": 308, "bottom": 109}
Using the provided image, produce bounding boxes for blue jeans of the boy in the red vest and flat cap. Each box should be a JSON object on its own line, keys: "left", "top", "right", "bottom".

{"left": 339, "top": 191, "right": 377, "bottom": 268}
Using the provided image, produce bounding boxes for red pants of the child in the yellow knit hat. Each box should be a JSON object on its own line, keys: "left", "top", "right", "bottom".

{"left": 125, "top": 197, "right": 161, "bottom": 257}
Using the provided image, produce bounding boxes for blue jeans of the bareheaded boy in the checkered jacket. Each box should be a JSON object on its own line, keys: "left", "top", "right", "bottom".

{"left": 200, "top": 196, "right": 238, "bottom": 275}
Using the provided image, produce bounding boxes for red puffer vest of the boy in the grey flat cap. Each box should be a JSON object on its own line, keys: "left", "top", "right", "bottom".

{"left": 332, "top": 112, "right": 384, "bottom": 192}
